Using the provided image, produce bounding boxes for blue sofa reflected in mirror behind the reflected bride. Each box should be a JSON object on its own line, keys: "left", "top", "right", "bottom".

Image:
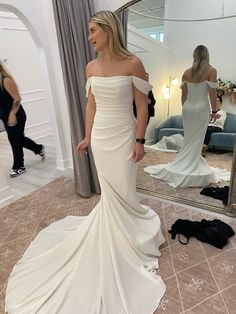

{"left": 155, "top": 112, "right": 236, "bottom": 151}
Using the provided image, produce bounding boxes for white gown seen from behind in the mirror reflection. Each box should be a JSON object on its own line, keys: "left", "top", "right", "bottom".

{"left": 144, "top": 81, "right": 230, "bottom": 187}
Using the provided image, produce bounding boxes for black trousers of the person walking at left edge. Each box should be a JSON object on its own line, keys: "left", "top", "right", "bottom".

{"left": 3, "top": 106, "right": 42, "bottom": 169}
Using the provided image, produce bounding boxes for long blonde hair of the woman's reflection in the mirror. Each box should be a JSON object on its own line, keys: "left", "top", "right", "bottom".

{"left": 191, "top": 45, "right": 210, "bottom": 81}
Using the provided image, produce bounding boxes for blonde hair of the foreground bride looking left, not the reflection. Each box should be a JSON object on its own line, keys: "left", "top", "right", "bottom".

{"left": 89, "top": 11, "right": 133, "bottom": 58}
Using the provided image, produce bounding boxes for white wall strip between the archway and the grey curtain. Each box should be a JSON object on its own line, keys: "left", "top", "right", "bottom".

{"left": 0, "top": 0, "right": 72, "bottom": 169}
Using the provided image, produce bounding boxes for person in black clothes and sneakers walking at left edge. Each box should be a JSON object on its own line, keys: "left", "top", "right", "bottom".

{"left": 0, "top": 61, "right": 45, "bottom": 178}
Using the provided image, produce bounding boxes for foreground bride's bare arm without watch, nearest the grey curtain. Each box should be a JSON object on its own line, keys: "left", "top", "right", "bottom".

{"left": 76, "top": 64, "right": 96, "bottom": 154}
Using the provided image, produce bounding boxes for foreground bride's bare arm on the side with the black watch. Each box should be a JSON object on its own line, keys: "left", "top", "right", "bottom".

{"left": 131, "top": 58, "right": 148, "bottom": 162}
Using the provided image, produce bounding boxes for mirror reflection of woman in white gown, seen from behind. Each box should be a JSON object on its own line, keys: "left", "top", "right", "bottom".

{"left": 144, "top": 45, "right": 230, "bottom": 187}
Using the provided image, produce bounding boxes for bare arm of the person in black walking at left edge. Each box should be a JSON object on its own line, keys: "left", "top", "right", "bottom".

{"left": 3, "top": 77, "right": 21, "bottom": 126}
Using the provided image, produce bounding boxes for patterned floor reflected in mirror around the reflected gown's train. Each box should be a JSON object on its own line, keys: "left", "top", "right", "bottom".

{"left": 137, "top": 151, "right": 232, "bottom": 209}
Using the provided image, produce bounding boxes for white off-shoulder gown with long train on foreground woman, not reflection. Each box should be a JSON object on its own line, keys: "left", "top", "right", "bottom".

{"left": 6, "top": 76, "right": 165, "bottom": 314}
